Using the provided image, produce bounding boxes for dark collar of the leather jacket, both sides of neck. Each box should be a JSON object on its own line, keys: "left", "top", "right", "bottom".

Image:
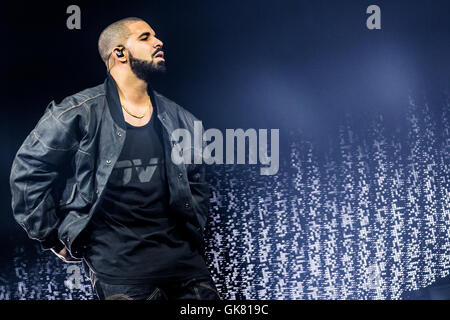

{"left": 105, "top": 72, "right": 166, "bottom": 130}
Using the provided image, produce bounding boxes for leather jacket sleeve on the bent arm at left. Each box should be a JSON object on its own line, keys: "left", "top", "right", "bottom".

{"left": 10, "top": 101, "right": 78, "bottom": 250}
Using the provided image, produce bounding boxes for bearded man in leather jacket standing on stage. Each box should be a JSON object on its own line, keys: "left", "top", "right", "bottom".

{"left": 10, "top": 18, "right": 220, "bottom": 299}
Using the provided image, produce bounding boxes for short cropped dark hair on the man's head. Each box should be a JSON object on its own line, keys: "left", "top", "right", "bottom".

{"left": 98, "top": 17, "right": 144, "bottom": 68}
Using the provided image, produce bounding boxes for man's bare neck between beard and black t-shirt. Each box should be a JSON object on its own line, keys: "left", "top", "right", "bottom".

{"left": 111, "top": 72, "right": 149, "bottom": 105}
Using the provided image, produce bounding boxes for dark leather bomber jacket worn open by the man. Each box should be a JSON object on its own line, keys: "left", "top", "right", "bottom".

{"left": 10, "top": 74, "right": 210, "bottom": 258}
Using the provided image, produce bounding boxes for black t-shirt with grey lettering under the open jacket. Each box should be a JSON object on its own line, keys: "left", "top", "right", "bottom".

{"left": 84, "top": 114, "right": 209, "bottom": 284}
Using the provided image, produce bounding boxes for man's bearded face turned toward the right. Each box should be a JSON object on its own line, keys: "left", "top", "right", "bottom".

{"left": 126, "top": 21, "right": 166, "bottom": 80}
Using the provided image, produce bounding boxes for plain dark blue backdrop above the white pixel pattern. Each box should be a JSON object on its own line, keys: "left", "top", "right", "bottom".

{"left": 0, "top": 0, "right": 450, "bottom": 300}
